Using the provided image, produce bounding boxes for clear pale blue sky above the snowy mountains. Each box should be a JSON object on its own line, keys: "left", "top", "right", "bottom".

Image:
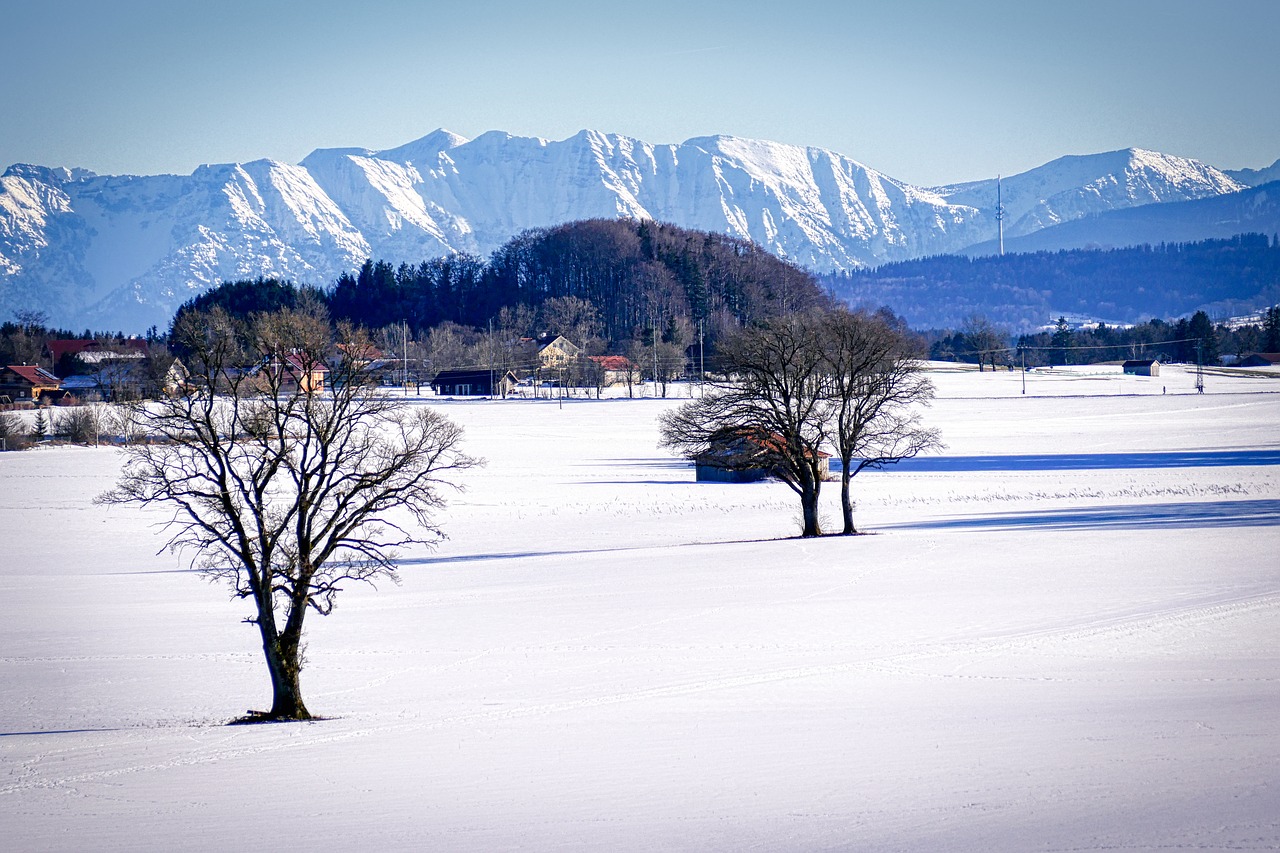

{"left": 0, "top": 0, "right": 1280, "bottom": 184}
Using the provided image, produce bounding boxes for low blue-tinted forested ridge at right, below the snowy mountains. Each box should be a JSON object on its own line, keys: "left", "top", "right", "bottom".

{"left": 820, "top": 234, "right": 1280, "bottom": 330}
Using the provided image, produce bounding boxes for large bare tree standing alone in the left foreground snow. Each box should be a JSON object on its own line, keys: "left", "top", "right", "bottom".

{"left": 99, "top": 306, "right": 476, "bottom": 720}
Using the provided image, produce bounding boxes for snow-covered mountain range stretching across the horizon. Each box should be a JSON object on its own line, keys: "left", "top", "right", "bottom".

{"left": 0, "top": 131, "right": 1280, "bottom": 330}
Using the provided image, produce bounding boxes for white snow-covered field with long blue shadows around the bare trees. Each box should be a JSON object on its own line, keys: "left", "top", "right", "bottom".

{"left": 0, "top": 368, "right": 1280, "bottom": 852}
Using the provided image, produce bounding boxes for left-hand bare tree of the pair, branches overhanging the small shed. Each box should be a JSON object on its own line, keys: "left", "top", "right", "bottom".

{"left": 660, "top": 313, "right": 829, "bottom": 537}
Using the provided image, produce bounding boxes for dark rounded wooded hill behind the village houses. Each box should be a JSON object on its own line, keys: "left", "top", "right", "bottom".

{"left": 172, "top": 219, "right": 828, "bottom": 343}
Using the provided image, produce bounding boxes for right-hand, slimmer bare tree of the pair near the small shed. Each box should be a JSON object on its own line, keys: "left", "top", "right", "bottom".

{"left": 823, "top": 310, "right": 942, "bottom": 535}
